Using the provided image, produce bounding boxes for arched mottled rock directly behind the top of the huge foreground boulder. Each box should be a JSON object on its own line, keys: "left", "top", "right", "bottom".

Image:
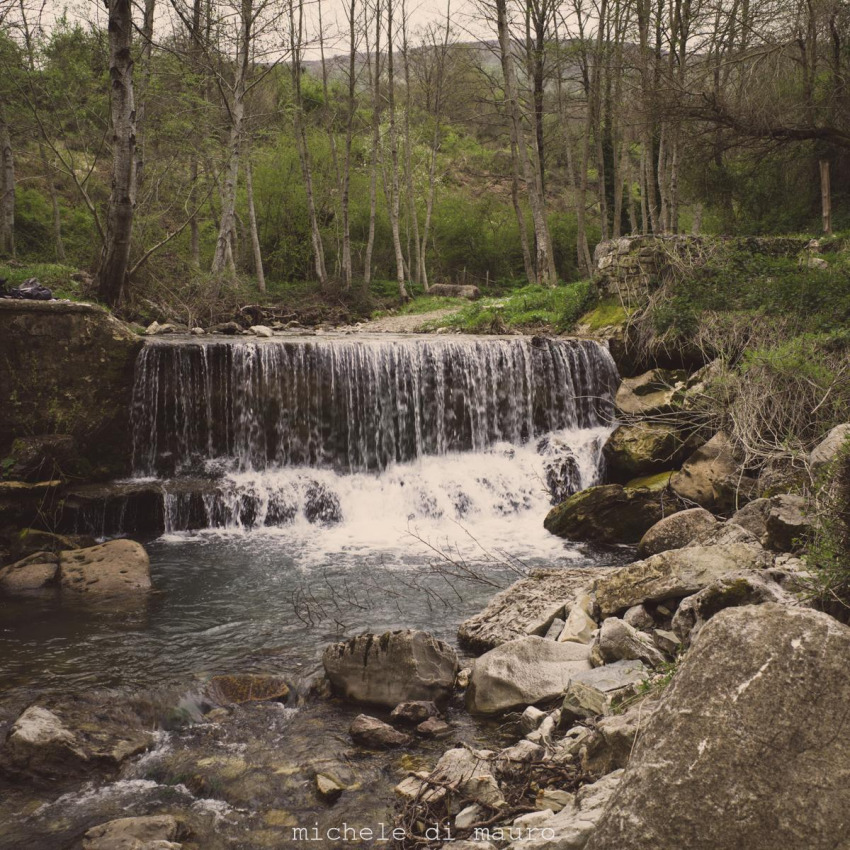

{"left": 673, "top": 571, "right": 797, "bottom": 646}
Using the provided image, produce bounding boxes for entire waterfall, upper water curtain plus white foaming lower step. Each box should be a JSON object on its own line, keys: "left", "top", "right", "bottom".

{"left": 122, "top": 336, "right": 617, "bottom": 532}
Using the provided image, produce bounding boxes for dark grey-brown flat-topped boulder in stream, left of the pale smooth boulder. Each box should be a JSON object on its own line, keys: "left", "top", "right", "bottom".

{"left": 322, "top": 629, "right": 459, "bottom": 708}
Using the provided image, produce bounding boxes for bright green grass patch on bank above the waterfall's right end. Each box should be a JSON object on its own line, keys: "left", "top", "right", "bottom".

{"left": 426, "top": 281, "right": 594, "bottom": 333}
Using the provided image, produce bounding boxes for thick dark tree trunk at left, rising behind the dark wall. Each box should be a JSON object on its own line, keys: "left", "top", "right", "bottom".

{"left": 98, "top": 0, "right": 136, "bottom": 307}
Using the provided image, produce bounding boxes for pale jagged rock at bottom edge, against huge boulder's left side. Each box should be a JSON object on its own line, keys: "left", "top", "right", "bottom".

{"left": 508, "top": 770, "right": 624, "bottom": 850}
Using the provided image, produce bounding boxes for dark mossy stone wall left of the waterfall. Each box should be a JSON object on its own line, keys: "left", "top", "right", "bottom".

{"left": 0, "top": 299, "right": 143, "bottom": 478}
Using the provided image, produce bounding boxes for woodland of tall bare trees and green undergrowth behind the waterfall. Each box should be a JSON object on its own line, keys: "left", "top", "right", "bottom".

{"left": 0, "top": 0, "right": 850, "bottom": 307}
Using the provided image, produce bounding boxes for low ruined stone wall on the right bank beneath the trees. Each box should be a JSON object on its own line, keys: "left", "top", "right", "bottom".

{"left": 593, "top": 234, "right": 809, "bottom": 306}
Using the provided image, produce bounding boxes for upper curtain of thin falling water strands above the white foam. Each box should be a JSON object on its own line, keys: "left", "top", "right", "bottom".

{"left": 132, "top": 337, "right": 616, "bottom": 476}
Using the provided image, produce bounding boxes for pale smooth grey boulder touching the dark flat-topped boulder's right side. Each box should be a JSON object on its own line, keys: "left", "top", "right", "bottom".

{"left": 466, "top": 636, "right": 590, "bottom": 714}
